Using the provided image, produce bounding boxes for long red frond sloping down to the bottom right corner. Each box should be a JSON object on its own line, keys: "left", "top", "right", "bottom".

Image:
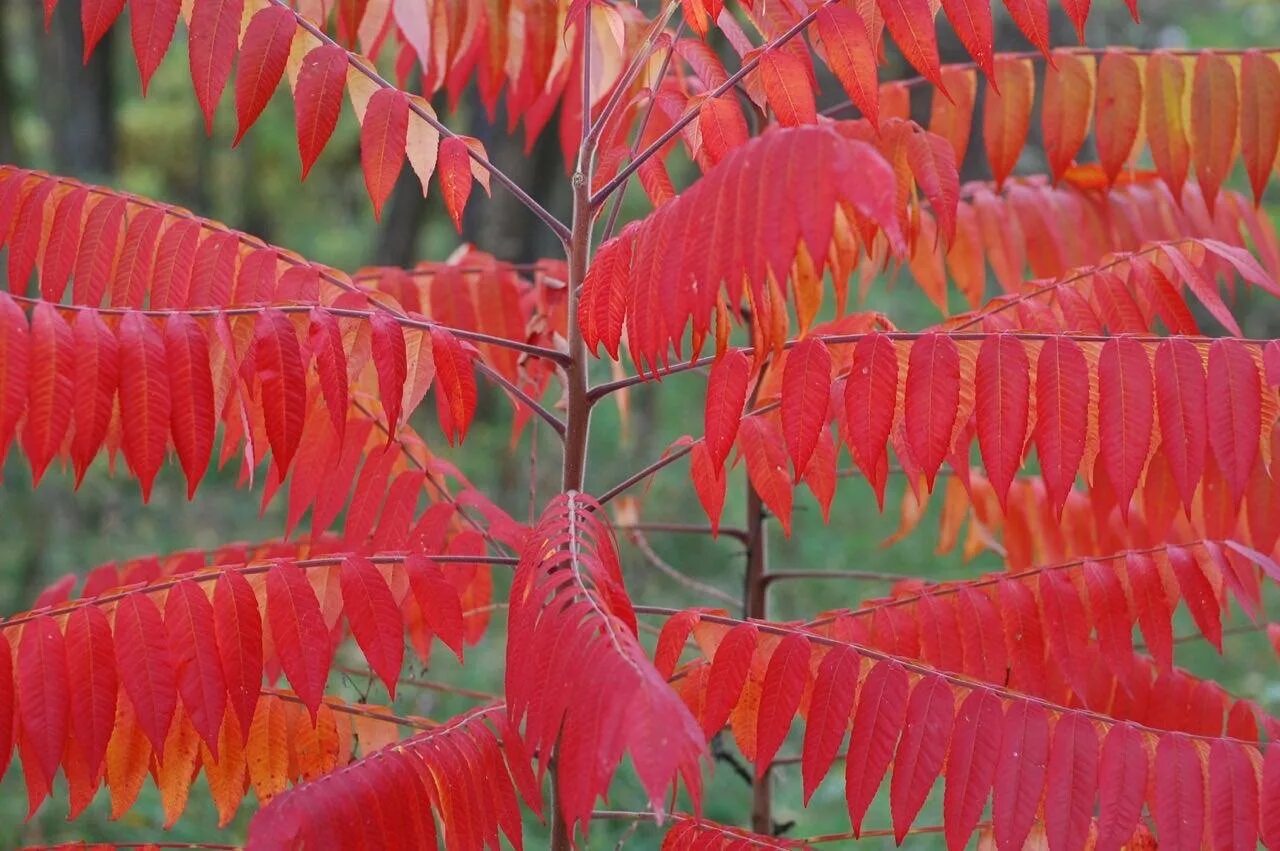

{"left": 658, "top": 612, "right": 1280, "bottom": 848}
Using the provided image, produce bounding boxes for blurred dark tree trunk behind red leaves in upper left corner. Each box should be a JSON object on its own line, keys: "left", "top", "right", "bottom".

{"left": 32, "top": 0, "right": 116, "bottom": 180}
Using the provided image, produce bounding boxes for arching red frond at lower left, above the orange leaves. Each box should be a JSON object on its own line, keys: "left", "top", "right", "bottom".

{"left": 0, "top": 554, "right": 488, "bottom": 818}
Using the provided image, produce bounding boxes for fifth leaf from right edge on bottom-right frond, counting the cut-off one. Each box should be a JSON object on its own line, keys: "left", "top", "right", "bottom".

{"left": 1044, "top": 713, "right": 1098, "bottom": 851}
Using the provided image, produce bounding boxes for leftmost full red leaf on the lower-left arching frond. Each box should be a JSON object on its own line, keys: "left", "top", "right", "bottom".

{"left": 17, "top": 614, "right": 69, "bottom": 787}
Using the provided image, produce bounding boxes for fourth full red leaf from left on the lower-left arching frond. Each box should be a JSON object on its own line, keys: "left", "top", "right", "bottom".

{"left": 164, "top": 580, "right": 227, "bottom": 758}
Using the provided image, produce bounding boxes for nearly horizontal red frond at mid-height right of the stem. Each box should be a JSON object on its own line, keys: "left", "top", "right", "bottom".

{"left": 692, "top": 331, "right": 1280, "bottom": 529}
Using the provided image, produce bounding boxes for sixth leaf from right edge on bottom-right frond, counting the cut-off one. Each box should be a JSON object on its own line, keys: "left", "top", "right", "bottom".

{"left": 992, "top": 700, "right": 1048, "bottom": 851}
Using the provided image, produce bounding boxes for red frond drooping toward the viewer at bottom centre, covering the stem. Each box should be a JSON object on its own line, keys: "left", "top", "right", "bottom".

{"left": 506, "top": 491, "right": 704, "bottom": 833}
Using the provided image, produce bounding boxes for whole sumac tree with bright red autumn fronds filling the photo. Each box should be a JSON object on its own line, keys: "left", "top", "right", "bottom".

{"left": 0, "top": 0, "right": 1280, "bottom": 851}
